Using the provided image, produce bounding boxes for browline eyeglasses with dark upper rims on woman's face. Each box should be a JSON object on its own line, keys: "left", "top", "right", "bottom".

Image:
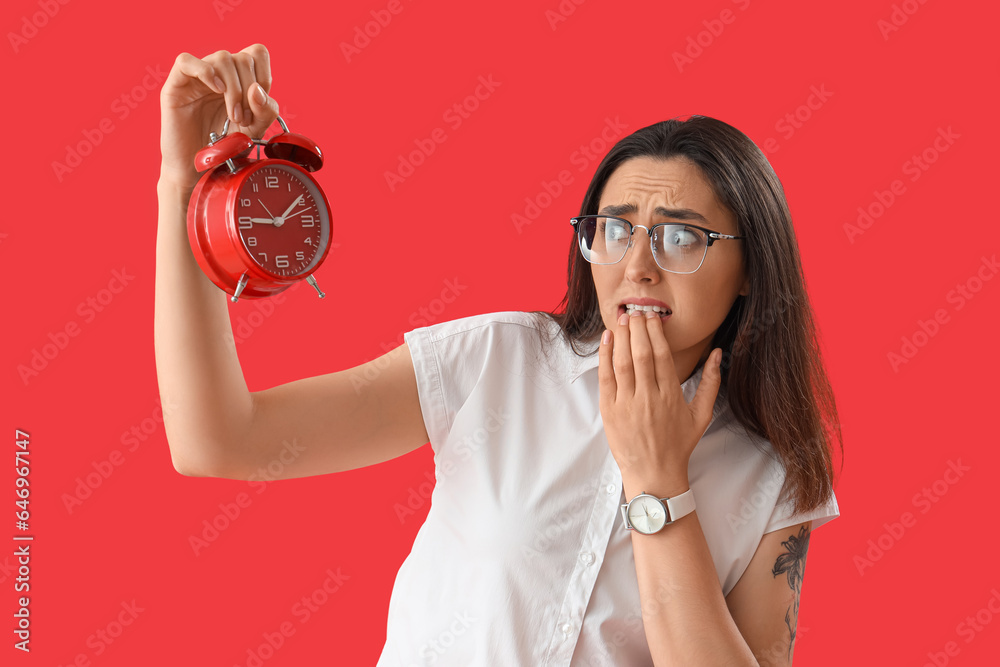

{"left": 569, "top": 215, "right": 746, "bottom": 273}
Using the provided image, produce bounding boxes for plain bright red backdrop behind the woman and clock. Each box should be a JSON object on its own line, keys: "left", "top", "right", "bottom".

{"left": 0, "top": 0, "right": 1000, "bottom": 667}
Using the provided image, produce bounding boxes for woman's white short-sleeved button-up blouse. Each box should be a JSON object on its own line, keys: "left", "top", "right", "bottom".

{"left": 378, "top": 312, "right": 840, "bottom": 667}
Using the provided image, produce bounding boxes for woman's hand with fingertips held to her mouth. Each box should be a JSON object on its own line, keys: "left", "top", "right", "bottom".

{"left": 598, "top": 311, "right": 722, "bottom": 495}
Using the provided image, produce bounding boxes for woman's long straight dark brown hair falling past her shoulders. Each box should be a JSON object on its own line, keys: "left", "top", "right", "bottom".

{"left": 534, "top": 116, "right": 843, "bottom": 513}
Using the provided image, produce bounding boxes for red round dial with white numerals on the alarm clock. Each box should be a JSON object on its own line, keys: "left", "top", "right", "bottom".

{"left": 236, "top": 164, "right": 330, "bottom": 278}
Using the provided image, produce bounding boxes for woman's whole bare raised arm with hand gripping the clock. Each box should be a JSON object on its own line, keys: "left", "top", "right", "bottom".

{"left": 154, "top": 44, "right": 427, "bottom": 479}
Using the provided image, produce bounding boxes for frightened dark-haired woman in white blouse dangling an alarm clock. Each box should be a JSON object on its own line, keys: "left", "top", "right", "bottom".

{"left": 155, "top": 45, "right": 840, "bottom": 665}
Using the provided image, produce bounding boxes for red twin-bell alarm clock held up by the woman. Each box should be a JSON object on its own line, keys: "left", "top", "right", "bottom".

{"left": 188, "top": 116, "right": 331, "bottom": 301}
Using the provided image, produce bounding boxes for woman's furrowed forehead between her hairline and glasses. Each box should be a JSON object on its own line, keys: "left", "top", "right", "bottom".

{"left": 600, "top": 157, "right": 736, "bottom": 232}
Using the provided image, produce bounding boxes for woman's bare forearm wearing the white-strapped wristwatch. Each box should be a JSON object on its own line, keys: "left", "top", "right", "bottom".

{"left": 625, "top": 479, "right": 757, "bottom": 667}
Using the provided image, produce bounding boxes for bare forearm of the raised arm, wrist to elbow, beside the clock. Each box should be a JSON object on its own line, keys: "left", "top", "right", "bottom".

{"left": 153, "top": 178, "right": 252, "bottom": 476}
